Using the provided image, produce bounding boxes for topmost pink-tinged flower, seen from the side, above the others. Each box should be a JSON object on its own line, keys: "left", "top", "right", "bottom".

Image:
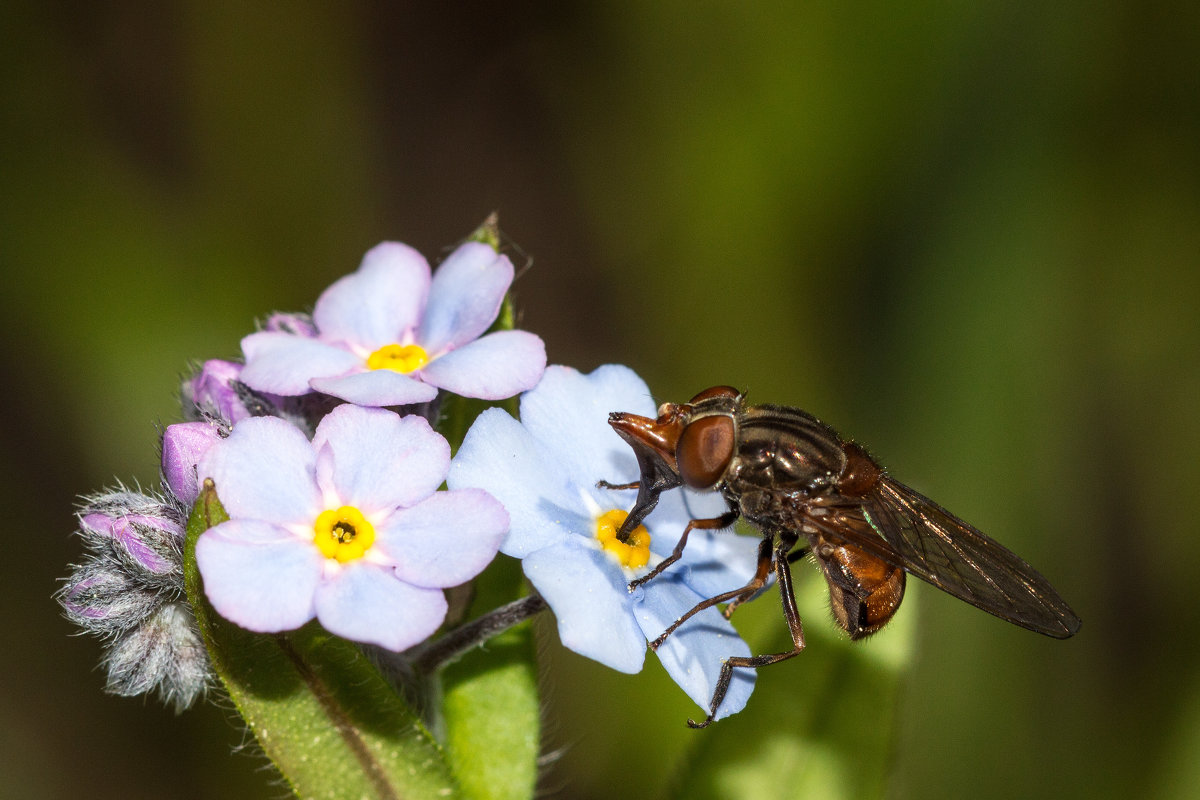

{"left": 240, "top": 242, "right": 546, "bottom": 405}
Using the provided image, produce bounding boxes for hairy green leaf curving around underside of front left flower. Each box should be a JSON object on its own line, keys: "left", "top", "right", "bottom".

{"left": 185, "top": 482, "right": 458, "bottom": 799}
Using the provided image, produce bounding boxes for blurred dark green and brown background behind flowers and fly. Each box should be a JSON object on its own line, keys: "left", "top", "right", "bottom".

{"left": 0, "top": 0, "right": 1200, "bottom": 798}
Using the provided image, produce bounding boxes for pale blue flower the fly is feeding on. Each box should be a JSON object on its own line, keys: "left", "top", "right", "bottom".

{"left": 448, "top": 366, "right": 758, "bottom": 718}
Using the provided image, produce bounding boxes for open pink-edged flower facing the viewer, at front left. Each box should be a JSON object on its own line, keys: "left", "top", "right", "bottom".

{"left": 196, "top": 405, "right": 509, "bottom": 650}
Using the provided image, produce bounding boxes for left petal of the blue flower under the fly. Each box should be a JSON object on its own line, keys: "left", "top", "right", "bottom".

{"left": 446, "top": 408, "right": 590, "bottom": 558}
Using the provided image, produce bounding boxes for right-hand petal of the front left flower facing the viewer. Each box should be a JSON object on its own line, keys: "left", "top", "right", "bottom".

{"left": 374, "top": 489, "right": 509, "bottom": 589}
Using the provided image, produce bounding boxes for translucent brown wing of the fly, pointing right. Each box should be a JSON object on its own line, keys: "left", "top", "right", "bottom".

{"left": 806, "top": 477, "right": 1080, "bottom": 639}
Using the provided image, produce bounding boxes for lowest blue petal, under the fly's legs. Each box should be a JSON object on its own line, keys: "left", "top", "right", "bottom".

{"left": 635, "top": 576, "right": 755, "bottom": 720}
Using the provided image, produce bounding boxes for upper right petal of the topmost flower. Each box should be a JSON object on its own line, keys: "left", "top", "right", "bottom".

{"left": 416, "top": 242, "right": 513, "bottom": 355}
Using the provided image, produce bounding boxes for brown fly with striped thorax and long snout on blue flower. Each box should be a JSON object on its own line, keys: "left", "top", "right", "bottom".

{"left": 600, "top": 386, "right": 1080, "bottom": 728}
